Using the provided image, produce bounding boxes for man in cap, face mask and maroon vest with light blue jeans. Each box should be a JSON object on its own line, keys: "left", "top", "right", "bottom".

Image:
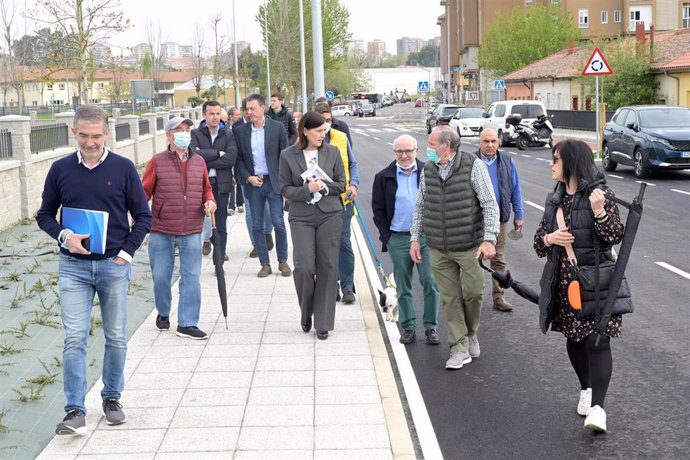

{"left": 142, "top": 117, "right": 216, "bottom": 340}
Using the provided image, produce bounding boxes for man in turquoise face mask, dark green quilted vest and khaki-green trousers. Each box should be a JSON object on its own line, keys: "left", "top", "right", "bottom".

{"left": 410, "top": 125, "right": 499, "bottom": 369}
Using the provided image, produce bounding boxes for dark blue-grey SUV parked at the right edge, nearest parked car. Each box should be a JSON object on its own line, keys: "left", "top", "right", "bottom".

{"left": 601, "top": 105, "right": 690, "bottom": 178}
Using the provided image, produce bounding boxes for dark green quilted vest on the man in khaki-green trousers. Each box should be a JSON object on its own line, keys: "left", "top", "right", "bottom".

{"left": 424, "top": 151, "right": 484, "bottom": 251}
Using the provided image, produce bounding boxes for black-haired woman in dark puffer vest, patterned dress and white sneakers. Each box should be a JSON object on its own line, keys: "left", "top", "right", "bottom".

{"left": 534, "top": 140, "right": 630, "bottom": 431}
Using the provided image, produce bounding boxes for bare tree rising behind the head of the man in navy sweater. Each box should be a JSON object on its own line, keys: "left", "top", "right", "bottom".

{"left": 30, "top": 0, "right": 131, "bottom": 103}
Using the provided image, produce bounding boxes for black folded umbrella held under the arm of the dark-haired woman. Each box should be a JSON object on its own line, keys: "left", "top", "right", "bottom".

{"left": 596, "top": 182, "right": 647, "bottom": 334}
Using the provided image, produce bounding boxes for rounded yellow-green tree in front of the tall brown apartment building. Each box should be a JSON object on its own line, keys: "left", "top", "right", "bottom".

{"left": 479, "top": 5, "right": 580, "bottom": 75}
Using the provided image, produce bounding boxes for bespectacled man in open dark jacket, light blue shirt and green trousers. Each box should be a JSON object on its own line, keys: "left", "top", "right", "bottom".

{"left": 371, "top": 134, "right": 441, "bottom": 345}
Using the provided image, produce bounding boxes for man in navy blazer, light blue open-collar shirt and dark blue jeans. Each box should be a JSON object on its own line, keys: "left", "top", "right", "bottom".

{"left": 235, "top": 94, "right": 292, "bottom": 278}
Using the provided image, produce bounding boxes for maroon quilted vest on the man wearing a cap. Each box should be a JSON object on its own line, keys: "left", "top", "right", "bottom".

{"left": 151, "top": 150, "right": 206, "bottom": 235}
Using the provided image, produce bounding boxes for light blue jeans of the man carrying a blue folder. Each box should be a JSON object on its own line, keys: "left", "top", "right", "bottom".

{"left": 59, "top": 254, "right": 132, "bottom": 413}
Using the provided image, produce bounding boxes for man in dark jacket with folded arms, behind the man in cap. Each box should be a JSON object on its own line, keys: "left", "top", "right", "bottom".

{"left": 190, "top": 101, "right": 237, "bottom": 260}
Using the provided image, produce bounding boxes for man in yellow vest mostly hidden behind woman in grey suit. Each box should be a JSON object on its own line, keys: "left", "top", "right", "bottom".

{"left": 315, "top": 102, "right": 359, "bottom": 304}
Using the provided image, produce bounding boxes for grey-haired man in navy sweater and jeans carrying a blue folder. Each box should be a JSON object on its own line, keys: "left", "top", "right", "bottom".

{"left": 36, "top": 105, "right": 151, "bottom": 435}
